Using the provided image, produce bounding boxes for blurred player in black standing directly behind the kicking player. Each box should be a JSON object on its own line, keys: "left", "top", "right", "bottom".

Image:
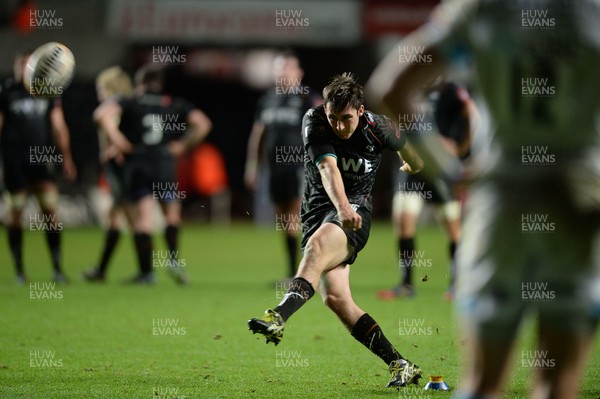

{"left": 244, "top": 52, "right": 323, "bottom": 278}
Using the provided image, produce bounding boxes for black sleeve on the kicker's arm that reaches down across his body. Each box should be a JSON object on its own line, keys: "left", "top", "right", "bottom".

{"left": 302, "top": 108, "right": 337, "bottom": 165}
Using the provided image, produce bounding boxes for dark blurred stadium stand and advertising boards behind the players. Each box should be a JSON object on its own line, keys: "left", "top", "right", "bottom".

{"left": 0, "top": 0, "right": 438, "bottom": 225}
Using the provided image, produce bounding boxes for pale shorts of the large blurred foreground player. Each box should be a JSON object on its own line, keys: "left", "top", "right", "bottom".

{"left": 456, "top": 178, "right": 600, "bottom": 339}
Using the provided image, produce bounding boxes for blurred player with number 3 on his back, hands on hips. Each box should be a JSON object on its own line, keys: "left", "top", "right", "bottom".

{"left": 98, "top": 66, "right": 212, "bottom": 284}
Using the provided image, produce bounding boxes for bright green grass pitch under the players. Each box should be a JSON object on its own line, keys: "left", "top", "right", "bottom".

{"left": 0, "top": 223, "right": 600, "bottom": 399}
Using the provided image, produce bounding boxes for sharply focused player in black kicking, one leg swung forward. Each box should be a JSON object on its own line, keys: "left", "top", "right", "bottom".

{"left": 248, "top": 74, "right": 423, "bottom": 387}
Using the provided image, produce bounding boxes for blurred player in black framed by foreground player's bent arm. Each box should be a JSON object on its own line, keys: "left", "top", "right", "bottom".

{"left": 377, "top": 81, "right": 478, "bottom": 300}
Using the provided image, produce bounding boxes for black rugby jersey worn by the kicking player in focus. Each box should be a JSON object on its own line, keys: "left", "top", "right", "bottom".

{"left": 302, "top": 105, "right": 406, "bottom": 213}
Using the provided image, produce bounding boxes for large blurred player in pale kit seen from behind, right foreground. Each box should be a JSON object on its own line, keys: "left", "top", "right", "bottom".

{"left": 367, "top": 0, "right": 600, "bottom": 399}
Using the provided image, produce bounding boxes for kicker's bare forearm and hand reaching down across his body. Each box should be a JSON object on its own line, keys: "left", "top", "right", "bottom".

{"left": 317, "top": 155, "right": 362, "bottom": 230}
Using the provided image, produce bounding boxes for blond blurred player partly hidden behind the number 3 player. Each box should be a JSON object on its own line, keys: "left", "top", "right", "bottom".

{"left": 83, "top": 66, "right": 134, "bottom": 281}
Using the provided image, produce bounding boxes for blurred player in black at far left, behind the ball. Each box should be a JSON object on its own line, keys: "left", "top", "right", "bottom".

{"left": 0, "top": 52, "right": 77, "bottom": 284}
